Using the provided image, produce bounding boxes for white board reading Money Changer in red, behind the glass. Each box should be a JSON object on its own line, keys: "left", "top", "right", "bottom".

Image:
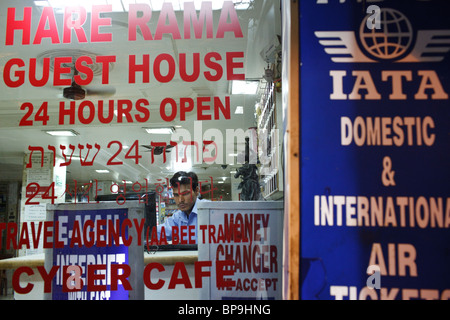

{"left": 198, "top": 201, "right": 283, "bottom": 300}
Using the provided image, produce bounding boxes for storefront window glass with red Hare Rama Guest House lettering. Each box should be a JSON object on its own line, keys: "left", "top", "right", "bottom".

{"left": 0, "top": 0, "right": 284, "bottom": 299}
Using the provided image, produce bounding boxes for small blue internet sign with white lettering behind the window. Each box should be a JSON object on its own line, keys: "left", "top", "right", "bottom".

{"left": 52, "top": 208, "right": 129, "bottom": 300}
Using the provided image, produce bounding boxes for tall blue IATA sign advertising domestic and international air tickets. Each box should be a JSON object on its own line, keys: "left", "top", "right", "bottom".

{"left": 299, "top": 0, "right": 450, "bottom": 300}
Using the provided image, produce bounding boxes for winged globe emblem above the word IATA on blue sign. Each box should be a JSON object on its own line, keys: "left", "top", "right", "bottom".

{"left": 314, "top": 8, "right": 450, "bottom": 63}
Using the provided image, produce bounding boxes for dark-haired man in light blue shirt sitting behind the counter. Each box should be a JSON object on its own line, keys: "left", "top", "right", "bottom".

{"left": 158, "top": 171, "right": 202, "bottom": 243}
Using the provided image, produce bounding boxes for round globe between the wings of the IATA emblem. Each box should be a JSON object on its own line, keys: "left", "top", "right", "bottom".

{"left": 359, "top": 8, "right": 413, "bottom": 60}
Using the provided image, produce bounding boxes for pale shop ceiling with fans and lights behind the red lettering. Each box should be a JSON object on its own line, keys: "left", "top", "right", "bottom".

{"left": 0, "top": 0, "right": 281, "bottom": 191}
